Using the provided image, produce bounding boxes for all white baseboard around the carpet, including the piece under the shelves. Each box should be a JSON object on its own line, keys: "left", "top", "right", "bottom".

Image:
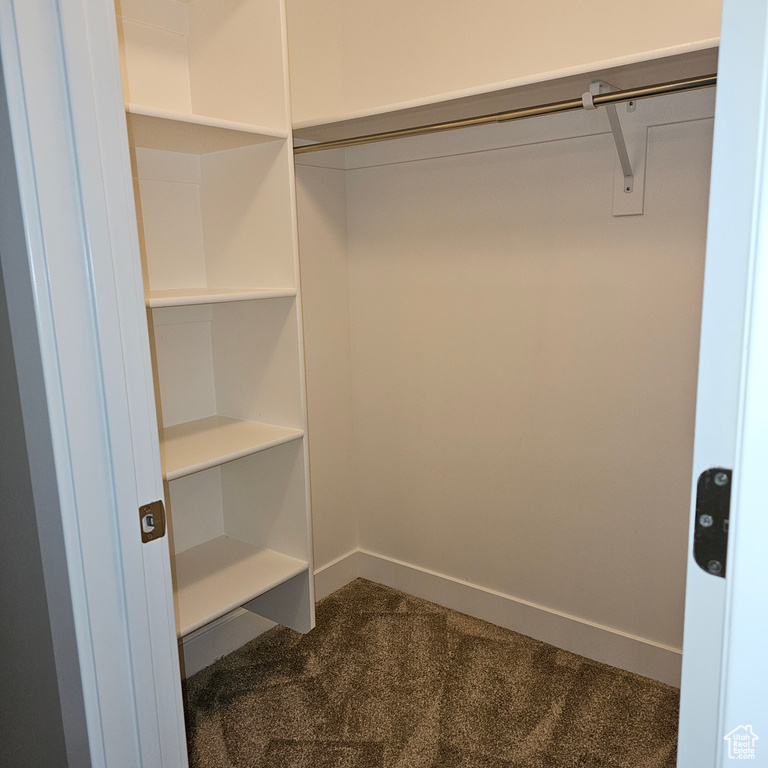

{"left": 178, "top": 549, "right": 682, "bottom": 686}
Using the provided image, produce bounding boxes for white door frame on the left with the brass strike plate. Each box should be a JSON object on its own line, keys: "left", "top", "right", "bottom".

{"left": 0, "top": 0, "right": 187, "bottom": 768}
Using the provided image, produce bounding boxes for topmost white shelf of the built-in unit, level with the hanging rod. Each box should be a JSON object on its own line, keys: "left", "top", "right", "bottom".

{"left": 125, "top": 104, "right": 288, "bottom": 155}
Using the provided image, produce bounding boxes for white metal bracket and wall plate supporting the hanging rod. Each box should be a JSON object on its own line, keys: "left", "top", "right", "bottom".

{"left": 581, "top": 80, "right": 646, "bottom": 216}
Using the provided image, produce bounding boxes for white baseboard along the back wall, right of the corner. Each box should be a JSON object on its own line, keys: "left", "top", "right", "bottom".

{"left": 352, "top": 549, "right": 682, "bottom": 686}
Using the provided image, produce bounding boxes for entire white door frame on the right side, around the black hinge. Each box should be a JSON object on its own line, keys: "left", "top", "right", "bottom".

{"left": 677, "top": 0, "right": 768, "bottom": 768}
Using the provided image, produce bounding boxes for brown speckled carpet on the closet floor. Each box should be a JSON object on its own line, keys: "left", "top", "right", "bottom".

{"left": 186, "top": 579, "right": 678, "bottom": 768}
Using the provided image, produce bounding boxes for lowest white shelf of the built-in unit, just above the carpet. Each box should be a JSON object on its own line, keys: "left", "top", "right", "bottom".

{"left": 175, "top": 536, "right": 308, "bottom": 637}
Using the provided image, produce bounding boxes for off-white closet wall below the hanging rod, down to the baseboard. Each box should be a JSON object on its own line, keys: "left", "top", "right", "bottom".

{"left": 299, "top": 92, "right": 714, "bottom": 664}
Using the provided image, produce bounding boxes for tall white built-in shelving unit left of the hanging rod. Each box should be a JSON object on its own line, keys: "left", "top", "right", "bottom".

{"left": 116, "top": 0, "right": 314, "bottom": 652}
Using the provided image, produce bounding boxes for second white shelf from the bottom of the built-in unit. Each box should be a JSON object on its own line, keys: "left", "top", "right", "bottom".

{"left": 161, "top": 416, "right": 304, "bottom": 480}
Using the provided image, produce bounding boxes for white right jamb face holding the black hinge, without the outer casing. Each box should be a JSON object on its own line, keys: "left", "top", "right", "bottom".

{"left": 677, "top": 0, "right": 768, "bottom": 768}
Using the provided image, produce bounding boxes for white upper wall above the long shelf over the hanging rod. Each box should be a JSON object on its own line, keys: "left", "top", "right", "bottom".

{"left": 287, "top": 0, "right": 721, "bottom": 123}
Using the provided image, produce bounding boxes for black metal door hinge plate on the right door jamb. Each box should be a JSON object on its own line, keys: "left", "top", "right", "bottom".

{"left": 693, "top": 467, "right": 733, "bottom": 578}
